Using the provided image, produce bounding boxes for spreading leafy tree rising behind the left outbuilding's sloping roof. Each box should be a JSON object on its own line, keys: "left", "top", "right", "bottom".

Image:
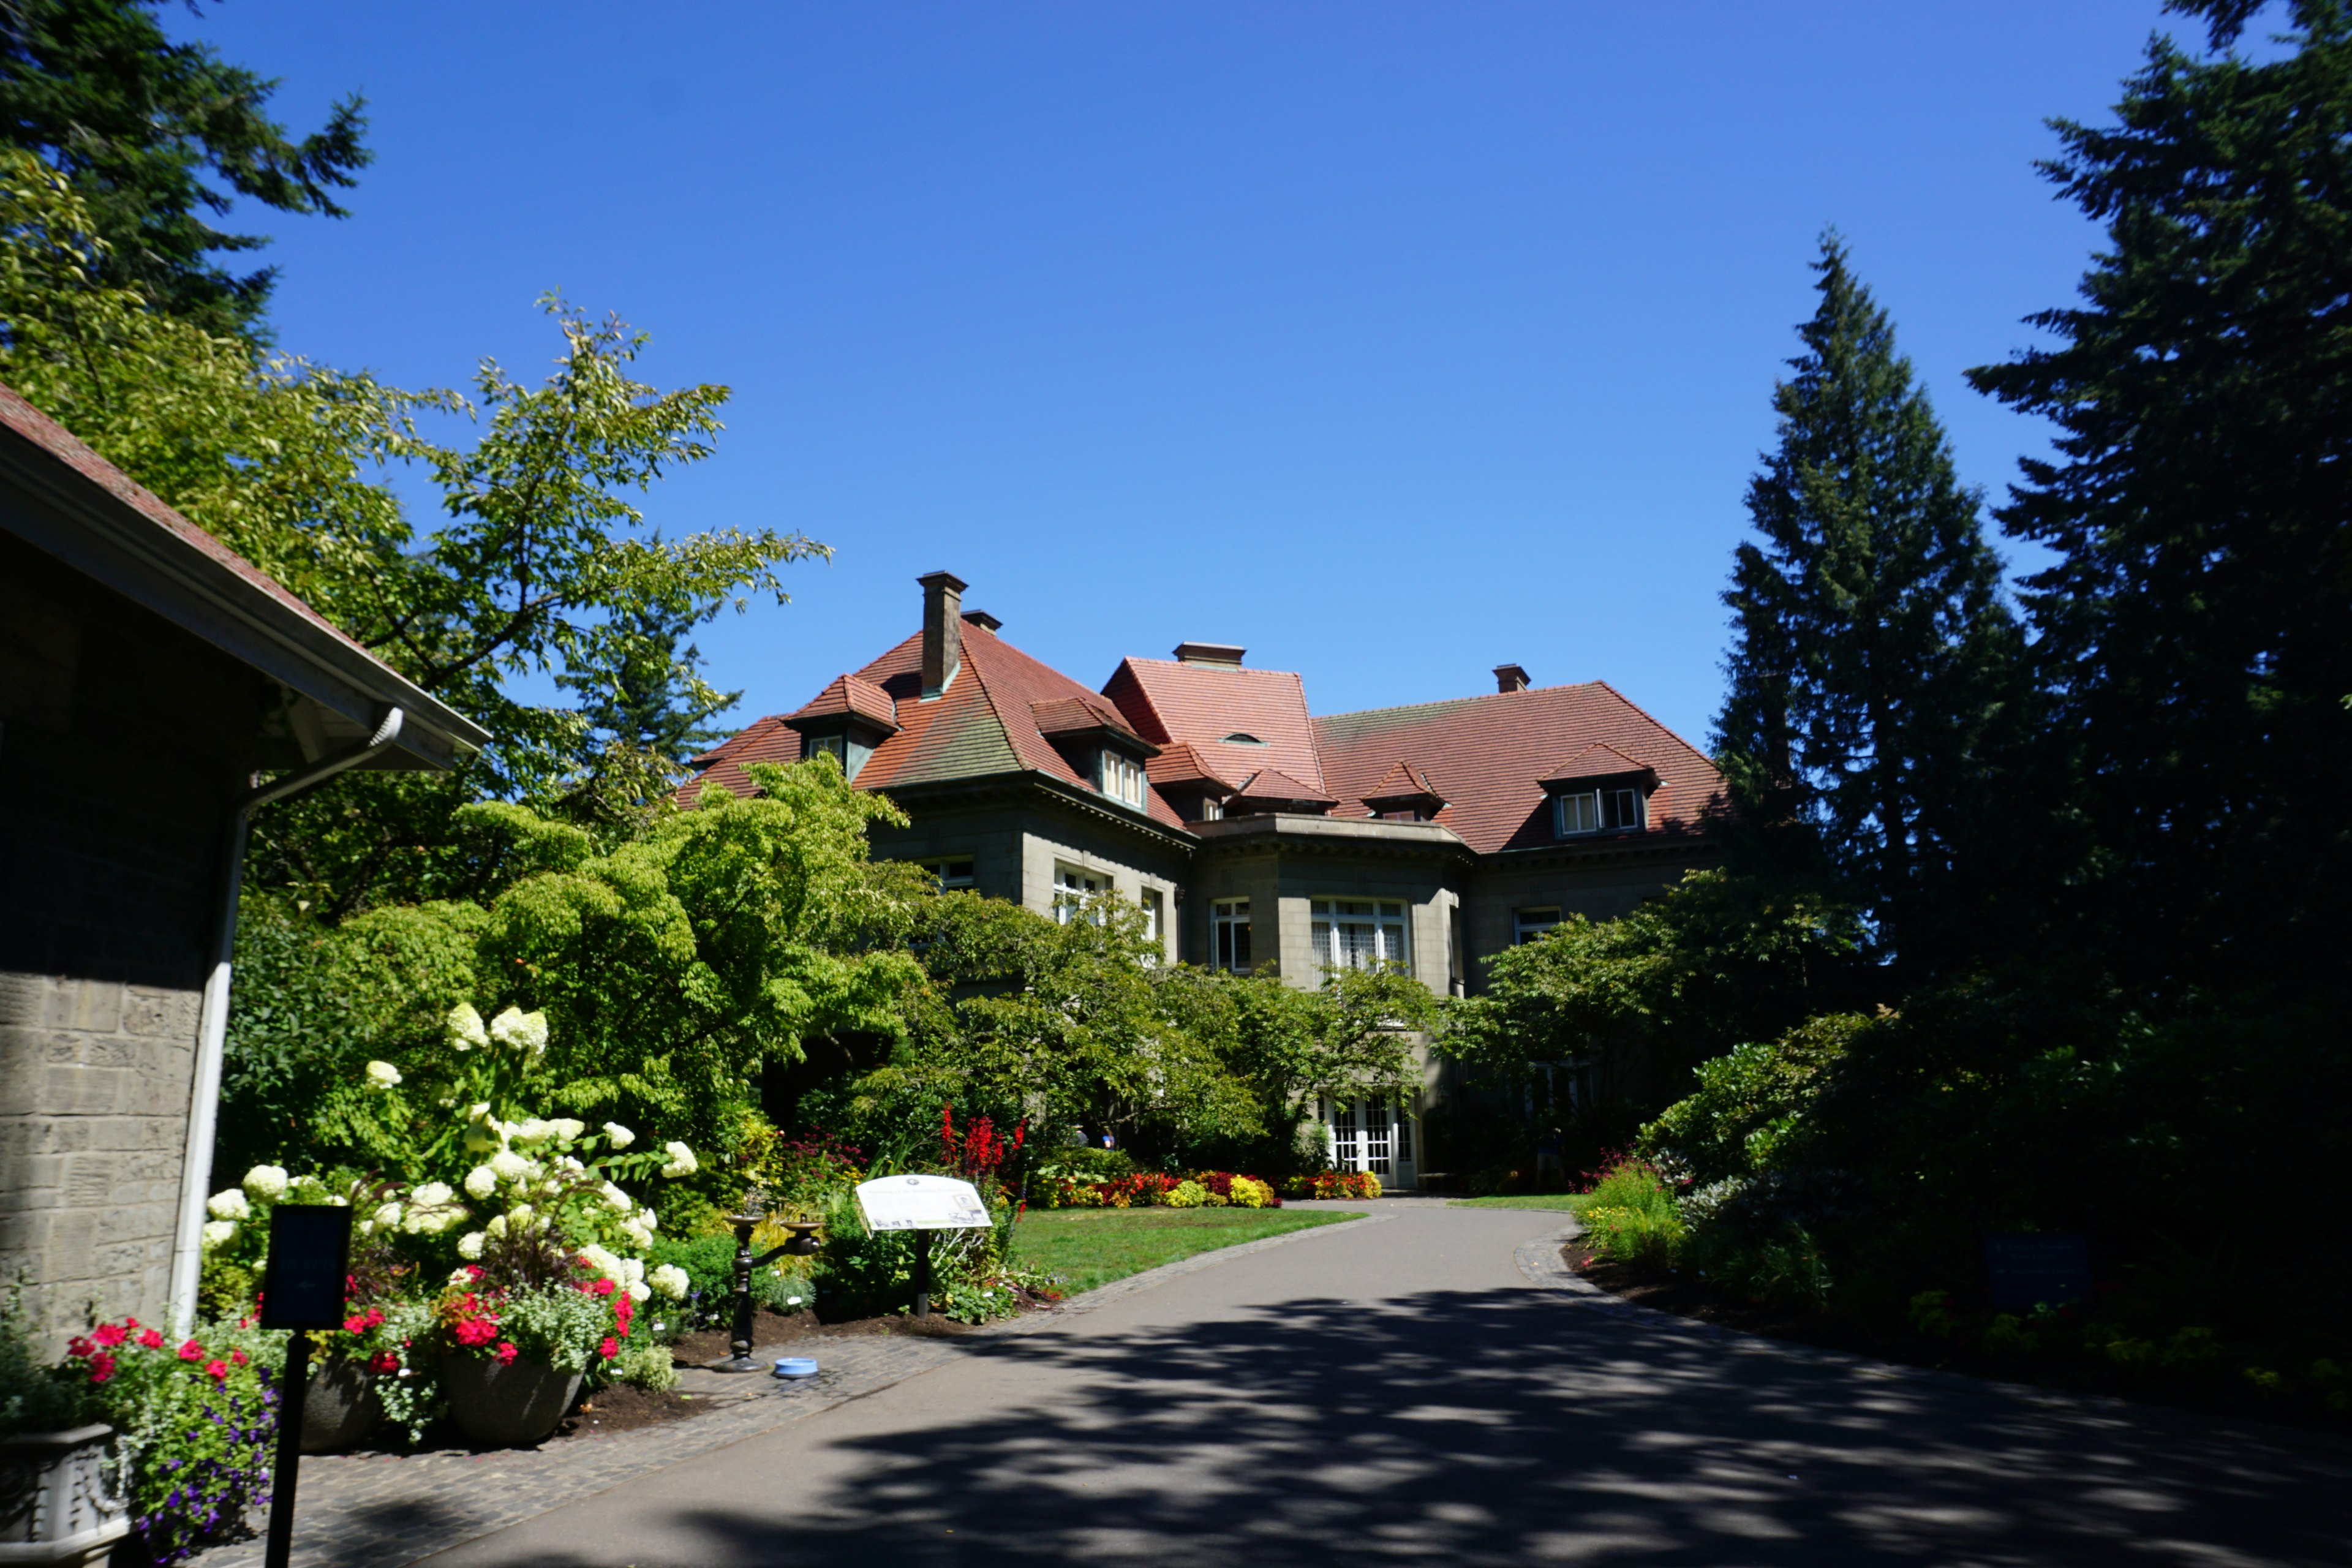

{"left": 0, "top": 153, "right": 828, "bottom": 919}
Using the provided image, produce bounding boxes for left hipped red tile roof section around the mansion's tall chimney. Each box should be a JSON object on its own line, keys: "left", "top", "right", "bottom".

{"left": 677, "top": 620, "right": 1181, "bottom": 827}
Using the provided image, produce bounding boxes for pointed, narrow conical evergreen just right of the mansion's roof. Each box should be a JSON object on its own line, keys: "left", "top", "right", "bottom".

{"left": 1714, "top": 235, "right": 2018, "bottom": 976}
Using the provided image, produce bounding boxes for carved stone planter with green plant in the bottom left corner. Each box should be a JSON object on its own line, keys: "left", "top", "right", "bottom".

{"left": 0, "top": 1286, "right": 132, "bottom": 1563}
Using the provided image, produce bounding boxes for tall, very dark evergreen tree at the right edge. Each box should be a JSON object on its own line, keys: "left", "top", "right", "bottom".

{"left": 1971, "top": 0, "right": 2352, "bottom": 995}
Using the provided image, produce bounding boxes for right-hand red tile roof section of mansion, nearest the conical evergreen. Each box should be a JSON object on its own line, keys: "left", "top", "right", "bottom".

{"left": 1315, "top": 682, "right": 1722, "bottom": 853}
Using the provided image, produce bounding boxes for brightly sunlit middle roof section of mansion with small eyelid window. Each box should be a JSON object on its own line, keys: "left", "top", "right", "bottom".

{"left": 1103, "top": 658, "right": 1327, "bottom": 797}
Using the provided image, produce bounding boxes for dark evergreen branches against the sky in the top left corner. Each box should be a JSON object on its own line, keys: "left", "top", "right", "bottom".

{"left": 0, "top": 0, "right": 372, "bottom": 336}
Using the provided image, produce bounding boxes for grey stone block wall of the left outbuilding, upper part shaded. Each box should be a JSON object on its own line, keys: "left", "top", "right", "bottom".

{"left": 0, "top": 533, "right": 268, "bottom": 1335}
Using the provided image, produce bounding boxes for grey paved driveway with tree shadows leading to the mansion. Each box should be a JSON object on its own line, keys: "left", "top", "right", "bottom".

{"left": 431, "top": 1201, "right": 2352, "bottom": 1568}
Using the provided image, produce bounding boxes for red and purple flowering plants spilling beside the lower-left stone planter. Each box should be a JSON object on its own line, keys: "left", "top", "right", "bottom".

{"left": 66, "top": 1316, "right": 285, "bottom": 1563}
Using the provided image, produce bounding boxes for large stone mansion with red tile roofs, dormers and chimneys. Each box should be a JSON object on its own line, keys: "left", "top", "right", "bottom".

{"left": 680, "top": 571, "right": 1722, "bottom": 1187}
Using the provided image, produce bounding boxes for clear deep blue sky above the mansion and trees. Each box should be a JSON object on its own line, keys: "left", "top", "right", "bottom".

{"left": 167, "top": 0, "right": 2185, "bottom": 743}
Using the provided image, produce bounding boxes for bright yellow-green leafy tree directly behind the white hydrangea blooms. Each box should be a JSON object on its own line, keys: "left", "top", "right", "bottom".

{"left": 221, "top": 760, "right": 927, "bottom": 1164}
